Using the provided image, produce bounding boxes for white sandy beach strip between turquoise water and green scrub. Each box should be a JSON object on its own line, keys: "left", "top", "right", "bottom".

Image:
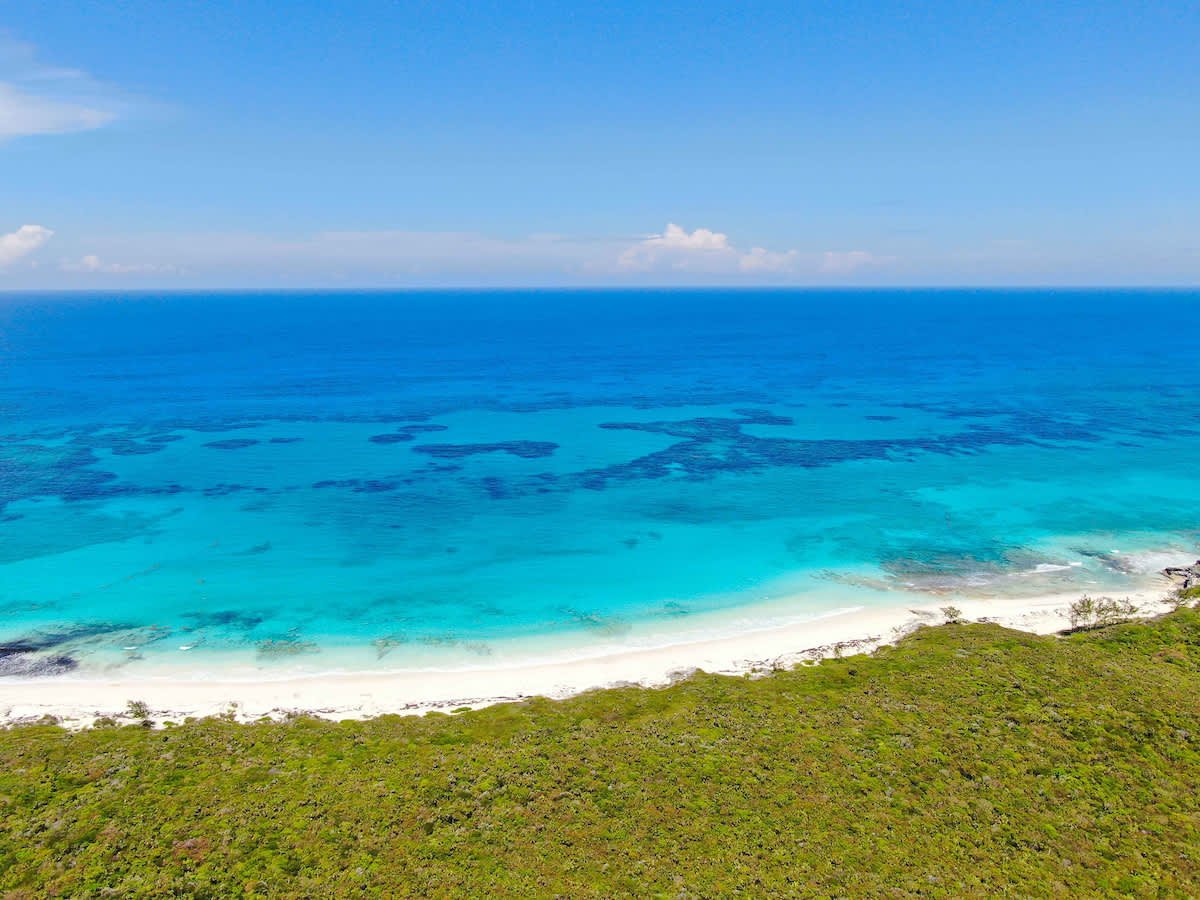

{"left": 0, "top": 583, "right": 1169, "bottom": 727}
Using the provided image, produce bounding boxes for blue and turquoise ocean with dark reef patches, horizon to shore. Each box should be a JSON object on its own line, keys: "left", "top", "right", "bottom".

{"left": 0, "top": 290, "right": 1200, "bottom": 678}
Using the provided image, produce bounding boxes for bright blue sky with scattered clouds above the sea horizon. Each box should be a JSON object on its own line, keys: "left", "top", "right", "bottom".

{"left": 0, "top": 0, "right": 1200, "bottom": 290}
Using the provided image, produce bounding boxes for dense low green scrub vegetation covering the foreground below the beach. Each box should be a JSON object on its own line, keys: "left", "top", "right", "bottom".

{"left": 0, "top": 607, "right": 1200, "bottom": 898}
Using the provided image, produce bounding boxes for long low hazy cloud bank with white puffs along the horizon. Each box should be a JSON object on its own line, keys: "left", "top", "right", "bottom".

{"left": 14, "top": 223, "right": 892, "bottom": 287}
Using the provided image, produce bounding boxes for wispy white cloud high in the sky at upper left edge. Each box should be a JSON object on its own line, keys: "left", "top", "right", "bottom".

{"left": 0, "top": 34, "right": 125, "bottom": 142}
